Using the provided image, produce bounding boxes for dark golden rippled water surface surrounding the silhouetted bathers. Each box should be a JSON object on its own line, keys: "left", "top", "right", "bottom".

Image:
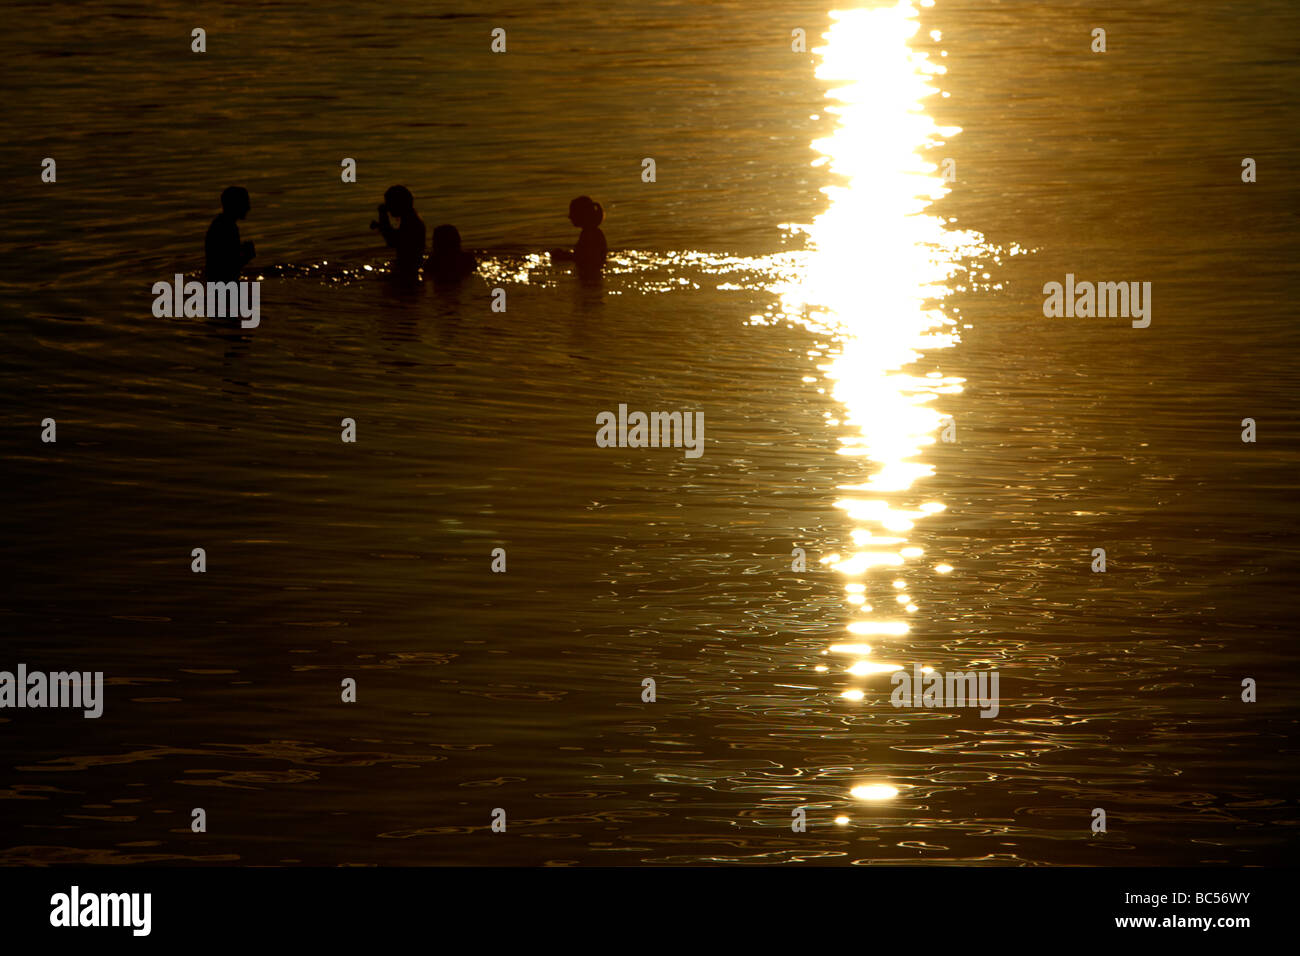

{"left": 0, "top": 0, "right": 1300, "bottom": 865}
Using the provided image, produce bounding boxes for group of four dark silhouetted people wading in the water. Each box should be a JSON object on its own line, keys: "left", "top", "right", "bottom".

{"left": 204, "top": 186, "right": 608, "bottom": 285}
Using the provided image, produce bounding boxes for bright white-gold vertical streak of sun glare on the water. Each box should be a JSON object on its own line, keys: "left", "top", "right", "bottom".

{"left": 776, "top": 0, "right": 989, "bottom": 801}
